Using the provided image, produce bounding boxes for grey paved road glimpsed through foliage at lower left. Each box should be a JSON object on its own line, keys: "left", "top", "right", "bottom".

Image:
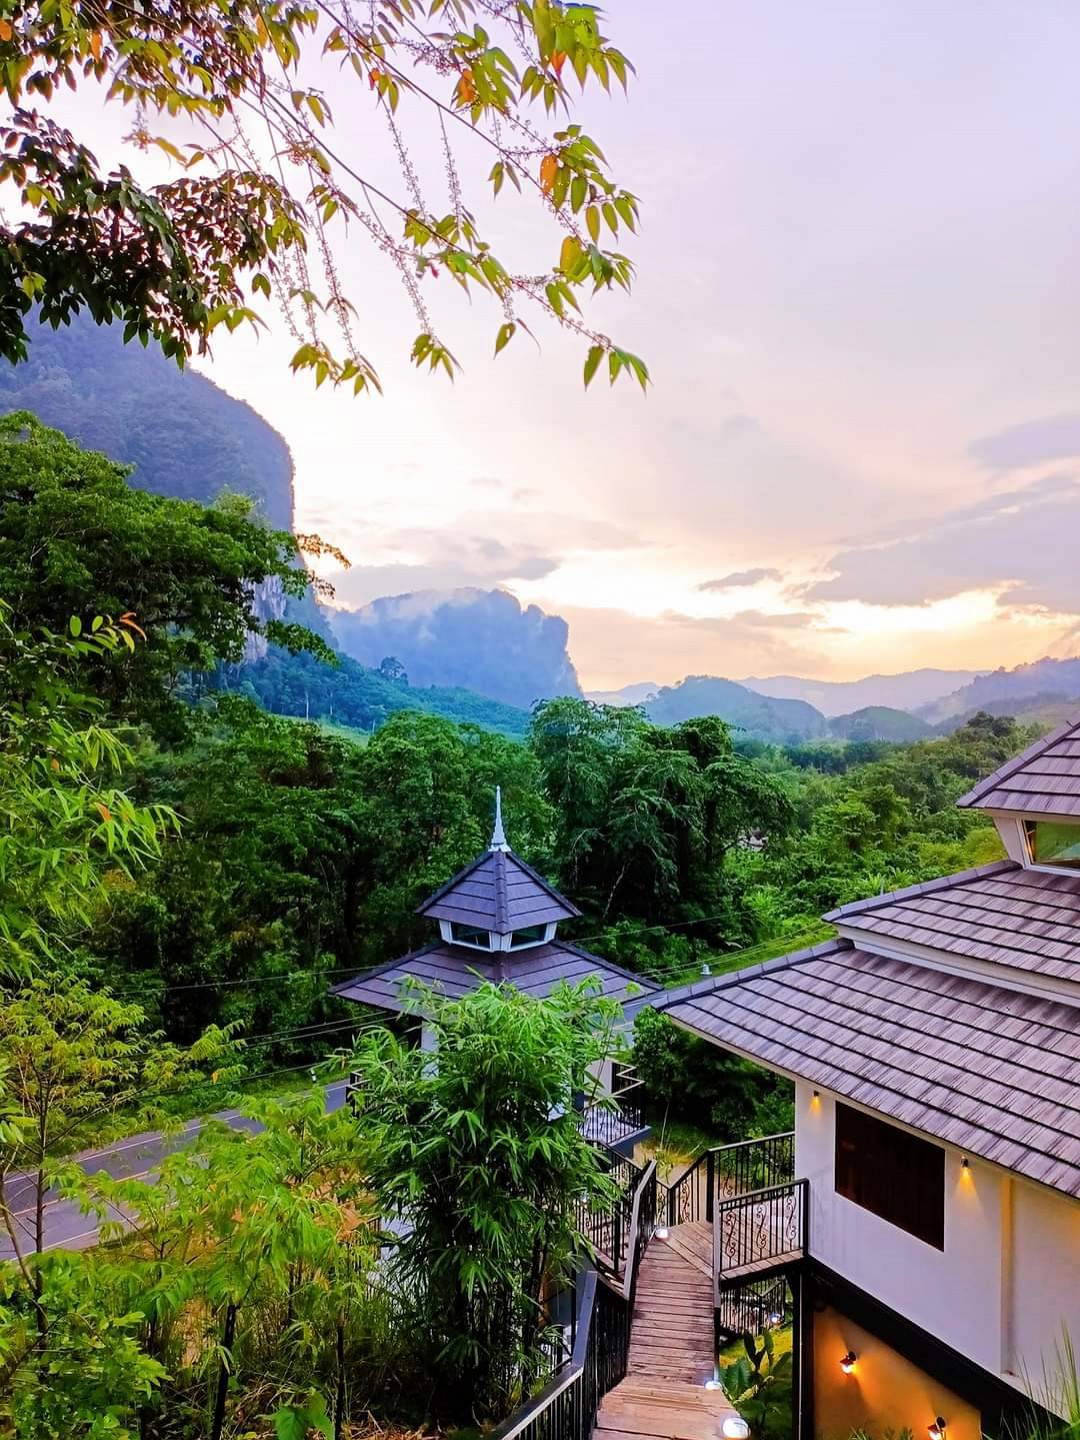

{"left": 0, "top": 1080, "right": 346, "bottom": 1260}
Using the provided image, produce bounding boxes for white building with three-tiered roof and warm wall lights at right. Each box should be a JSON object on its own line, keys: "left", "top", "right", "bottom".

{"left": 657, "top": 724, "right": 1080, "bottom": 1440}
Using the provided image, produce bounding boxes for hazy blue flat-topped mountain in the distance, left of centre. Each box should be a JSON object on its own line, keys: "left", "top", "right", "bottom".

{"left": 330, "top": 589, "right": 582, "bottom": 708}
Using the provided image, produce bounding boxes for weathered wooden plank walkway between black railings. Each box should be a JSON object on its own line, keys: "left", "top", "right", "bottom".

{"left": 595, "top": 1223, "right": 739, "bottom": 1440}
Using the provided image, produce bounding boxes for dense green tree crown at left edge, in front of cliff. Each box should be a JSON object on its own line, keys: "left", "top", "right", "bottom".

{"left": 0, "top": 412, "right": 338, "bottom": 731}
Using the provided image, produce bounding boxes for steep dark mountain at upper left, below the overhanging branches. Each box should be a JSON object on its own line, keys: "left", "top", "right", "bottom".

{"left": 0, "top": 317, "right": 292, "bottom": 530}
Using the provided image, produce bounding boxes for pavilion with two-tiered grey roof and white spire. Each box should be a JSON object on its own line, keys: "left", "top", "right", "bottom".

{"left": 333, "top": 792, "right": 660, "bottom": 1149}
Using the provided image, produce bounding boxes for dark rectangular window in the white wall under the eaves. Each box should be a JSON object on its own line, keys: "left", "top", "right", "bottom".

{"left": 835, "top": 1104, "right": 945, "bottom": 1250}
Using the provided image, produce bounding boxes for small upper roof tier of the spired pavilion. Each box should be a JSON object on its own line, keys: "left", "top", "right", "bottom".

{"left": 416, "top": 850, "right": 582, "bottom": 935}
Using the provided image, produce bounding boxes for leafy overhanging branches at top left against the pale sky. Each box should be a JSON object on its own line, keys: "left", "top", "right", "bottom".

{"left": 0, "top": 0, "right": 647, "bottom": 390}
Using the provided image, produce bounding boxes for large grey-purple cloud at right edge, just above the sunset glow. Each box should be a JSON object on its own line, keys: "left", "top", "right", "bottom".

{"left": 802, "top": 475, "right": 1080, "bottom": 613}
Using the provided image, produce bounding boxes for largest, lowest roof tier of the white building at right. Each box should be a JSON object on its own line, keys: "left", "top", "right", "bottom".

{"left": 658, "top": 942, "right": 1080, "bottom": 1197}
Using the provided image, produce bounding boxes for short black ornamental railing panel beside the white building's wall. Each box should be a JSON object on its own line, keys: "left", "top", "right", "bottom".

{"left": 713, "top": 1179, "right": 809, "bottom": 1305}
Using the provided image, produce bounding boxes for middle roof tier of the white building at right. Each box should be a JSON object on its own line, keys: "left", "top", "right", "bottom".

{"left": 825, "top": 860, "right": 1080, "bottom": 984}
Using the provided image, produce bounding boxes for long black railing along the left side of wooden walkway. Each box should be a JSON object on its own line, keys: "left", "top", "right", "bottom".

{"left": 491, "top": 1162, "right": 657, "bottom": 1440}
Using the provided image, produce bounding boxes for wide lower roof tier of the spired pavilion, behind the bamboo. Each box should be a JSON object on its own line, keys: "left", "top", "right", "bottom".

{"left": 333, "top": 940, "right": 657, "bottom": 1012}
